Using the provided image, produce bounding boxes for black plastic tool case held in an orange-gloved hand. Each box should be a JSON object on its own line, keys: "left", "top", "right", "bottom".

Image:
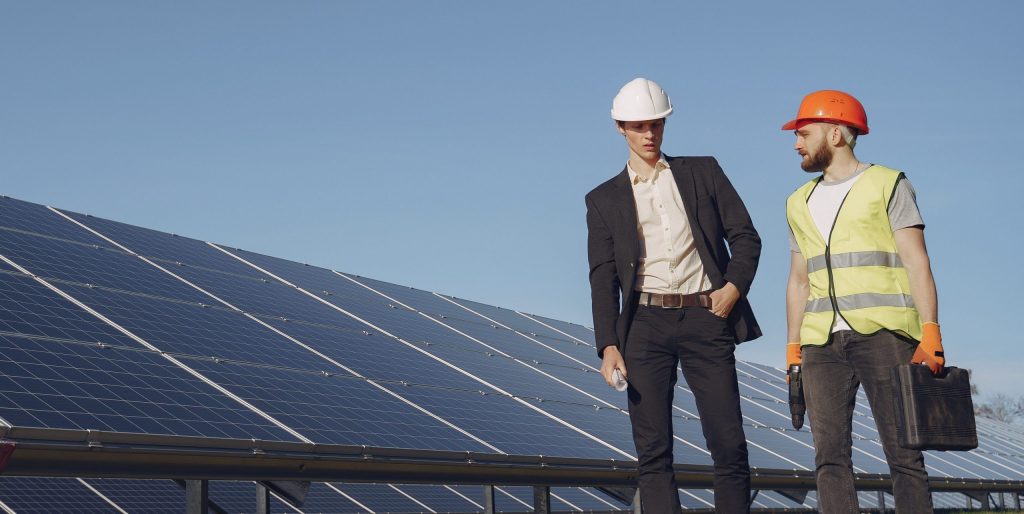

{"left": 892, "top": 365, "right": 978, "bottom": 451}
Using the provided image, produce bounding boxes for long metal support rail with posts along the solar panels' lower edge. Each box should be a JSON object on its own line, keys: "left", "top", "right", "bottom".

{"left": 0, "top": 428, "right": 1024, "bottom": 512}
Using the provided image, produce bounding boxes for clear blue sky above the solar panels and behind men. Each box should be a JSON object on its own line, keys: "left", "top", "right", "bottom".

{"left": 0, "top": 0, "right": 1024, "bottom": 396}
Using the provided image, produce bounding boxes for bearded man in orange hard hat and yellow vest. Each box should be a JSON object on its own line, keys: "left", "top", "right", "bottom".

{"left": 782, "top": 90, "right": 945, "bottom": 514}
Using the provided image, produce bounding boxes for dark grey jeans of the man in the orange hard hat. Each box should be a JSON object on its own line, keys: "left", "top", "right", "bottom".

{"left": 803, "top": 331, "right": 932, "bottom": 514}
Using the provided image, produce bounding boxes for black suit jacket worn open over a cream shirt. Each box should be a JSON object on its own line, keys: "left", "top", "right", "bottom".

{"left": 587, "top": 157, "right": 761, "bottom": 355}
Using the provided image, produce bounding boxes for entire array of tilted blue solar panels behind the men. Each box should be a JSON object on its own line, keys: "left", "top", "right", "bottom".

{"left": 0, "top": 198, "right": 1024, "bottom": 513}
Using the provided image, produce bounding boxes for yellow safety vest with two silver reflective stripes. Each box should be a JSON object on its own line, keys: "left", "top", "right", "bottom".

{"left": 786, "top": 165, "right": 921, "bottom": 345}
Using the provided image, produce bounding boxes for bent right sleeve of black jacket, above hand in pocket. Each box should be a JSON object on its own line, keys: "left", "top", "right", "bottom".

{"left": 712, "top": 159, "right": 761, "bottom": 297}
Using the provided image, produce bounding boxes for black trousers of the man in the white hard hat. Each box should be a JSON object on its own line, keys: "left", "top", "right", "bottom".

{"left": 624, "top": 306, "right": 751, "bottom": 514}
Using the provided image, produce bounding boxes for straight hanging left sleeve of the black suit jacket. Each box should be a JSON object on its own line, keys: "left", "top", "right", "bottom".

{"left": 586, "top": 196, "right": 620, "bottom": 356}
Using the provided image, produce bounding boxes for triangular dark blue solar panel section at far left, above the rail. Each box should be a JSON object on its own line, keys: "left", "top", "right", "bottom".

{"left": 0, "top": 272, "right": 295, "bottom": 440}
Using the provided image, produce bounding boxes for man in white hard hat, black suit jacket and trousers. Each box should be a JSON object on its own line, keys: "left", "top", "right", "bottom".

{"left": 587, "top": 79, "right": 761, "bottom": 514}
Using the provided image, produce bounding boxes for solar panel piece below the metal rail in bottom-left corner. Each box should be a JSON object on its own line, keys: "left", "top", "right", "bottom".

{"left": 0, "top": 476, "right": 118, "bottom": 514}
